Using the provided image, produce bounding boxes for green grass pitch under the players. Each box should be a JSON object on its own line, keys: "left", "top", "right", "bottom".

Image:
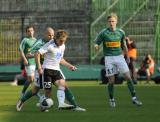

{"left": 0, "top": 81, "right": 160, "bottom": 122}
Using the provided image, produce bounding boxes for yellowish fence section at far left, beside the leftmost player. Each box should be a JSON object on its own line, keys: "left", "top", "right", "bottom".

{"left": 0, "top": 17, "right": 22, "bottom": 64}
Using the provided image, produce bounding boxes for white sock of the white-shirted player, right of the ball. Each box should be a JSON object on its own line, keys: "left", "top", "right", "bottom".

{"left": 57, "top": 86, "right": 65, "bottom": 104}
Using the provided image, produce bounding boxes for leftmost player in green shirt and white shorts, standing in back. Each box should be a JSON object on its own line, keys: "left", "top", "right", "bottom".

{"left": 19, "top": 26, "right": 36, "bottom": 96}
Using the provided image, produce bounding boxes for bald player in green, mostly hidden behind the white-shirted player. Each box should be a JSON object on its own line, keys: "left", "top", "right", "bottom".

{"left": 16, "top": 27, "right": 85, "bottom": 111}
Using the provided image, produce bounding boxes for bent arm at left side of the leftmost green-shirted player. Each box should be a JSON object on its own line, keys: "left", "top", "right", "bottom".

{"left": 19, "top": 40, "right": 28, "bottom": 65}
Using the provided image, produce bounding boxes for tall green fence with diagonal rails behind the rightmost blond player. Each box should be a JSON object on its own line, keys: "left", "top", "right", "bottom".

{"left": 90, "top": 0, "right": 158, "bottom": 64}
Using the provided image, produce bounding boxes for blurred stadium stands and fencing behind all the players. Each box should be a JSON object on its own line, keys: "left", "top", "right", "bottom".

{"left": 0, "top": 0, "right": 160, "bottom": 79}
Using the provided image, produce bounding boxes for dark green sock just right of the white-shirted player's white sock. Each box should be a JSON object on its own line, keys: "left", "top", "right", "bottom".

{"left": 64, "top": 87, "right": 77, "bottom": 107}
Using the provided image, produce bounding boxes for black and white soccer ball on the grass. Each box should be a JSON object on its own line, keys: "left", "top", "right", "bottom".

{"left": 40, "top": 98, "right": 54, "bottom": 109}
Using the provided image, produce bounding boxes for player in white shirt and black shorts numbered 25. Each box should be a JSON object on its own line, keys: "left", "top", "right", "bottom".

{"left": 35, "top": 30, "right": 86, "bottom": 111}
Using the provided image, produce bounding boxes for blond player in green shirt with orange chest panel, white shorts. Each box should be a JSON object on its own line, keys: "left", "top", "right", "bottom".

{"left": 94, "top": 13, "right": 142, "bottom": 107}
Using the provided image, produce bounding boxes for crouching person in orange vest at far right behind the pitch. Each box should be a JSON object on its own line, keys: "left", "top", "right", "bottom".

{"left": 138, "top": 54, "right": 155, "bottom": 83}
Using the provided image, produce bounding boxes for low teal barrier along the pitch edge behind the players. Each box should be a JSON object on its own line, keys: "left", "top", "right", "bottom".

{"left": 0, "top": 65, "right": 103, "bottom": 81}
